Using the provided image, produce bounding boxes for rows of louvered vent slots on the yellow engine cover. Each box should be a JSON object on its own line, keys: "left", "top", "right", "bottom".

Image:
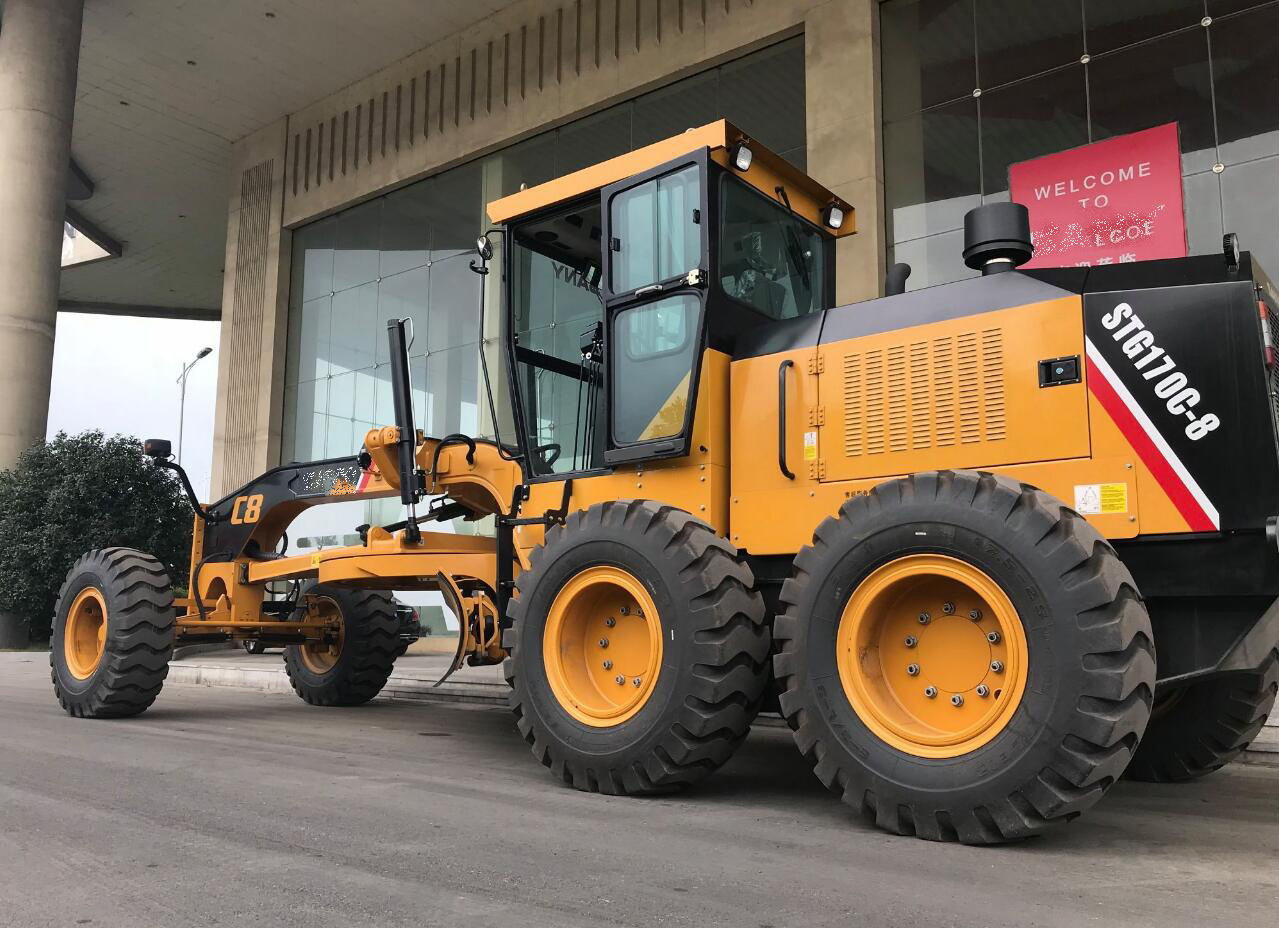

{"left": 843, "top": 329, "right": 1008, "bottom": 458}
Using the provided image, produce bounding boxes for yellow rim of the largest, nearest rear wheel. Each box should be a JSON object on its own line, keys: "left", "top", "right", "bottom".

{"left": 836, "top": 555, "right": 1028, "bottom": 758}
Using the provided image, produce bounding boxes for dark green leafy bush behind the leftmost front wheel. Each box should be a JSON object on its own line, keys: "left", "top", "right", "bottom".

{"left": 0, "top": 432, "right": 192, "bottom": 640}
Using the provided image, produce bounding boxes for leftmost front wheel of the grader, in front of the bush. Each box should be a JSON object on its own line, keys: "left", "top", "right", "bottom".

{"left": 49, "top": 547, "right": 175, "bottom": 718}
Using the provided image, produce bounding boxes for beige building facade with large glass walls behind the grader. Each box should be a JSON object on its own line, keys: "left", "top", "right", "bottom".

{"left": 204, "top": 0, "right": 1279, "bottom": 587}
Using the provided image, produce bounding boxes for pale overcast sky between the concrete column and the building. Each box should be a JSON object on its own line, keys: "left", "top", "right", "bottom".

{"left": 49, "top": 313, "right": 219, "bottom": 500}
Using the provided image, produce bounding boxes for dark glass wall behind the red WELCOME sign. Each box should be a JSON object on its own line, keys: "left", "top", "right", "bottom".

{"left": 880, "top": 0, "right": 1279, "bottom": 289}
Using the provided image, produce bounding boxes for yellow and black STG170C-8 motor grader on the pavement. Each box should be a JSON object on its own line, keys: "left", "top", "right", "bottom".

{"left": 51, "top": 121, "right": 1279, "bottom": 844}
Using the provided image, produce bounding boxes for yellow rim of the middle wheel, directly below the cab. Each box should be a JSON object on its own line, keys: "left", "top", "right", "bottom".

{"left": 542, "top": 566, "right": 663, "bottom": 729}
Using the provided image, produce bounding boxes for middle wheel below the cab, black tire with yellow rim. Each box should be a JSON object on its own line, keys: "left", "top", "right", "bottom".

{"left": 504, "top": 501, "right": 770, "bottom": 795}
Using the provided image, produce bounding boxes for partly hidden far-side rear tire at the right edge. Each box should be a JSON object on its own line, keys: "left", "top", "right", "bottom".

{"left": 1126, "top": 651, "right": 1279, "bottom": 782}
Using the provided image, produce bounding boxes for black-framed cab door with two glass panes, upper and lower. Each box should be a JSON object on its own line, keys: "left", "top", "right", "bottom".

{"left": 601, "top": 156, "right": 710, "bottom": 464}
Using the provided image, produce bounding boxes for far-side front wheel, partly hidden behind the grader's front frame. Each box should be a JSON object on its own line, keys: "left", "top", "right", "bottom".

{"left": 284, "top": 582, "right": 399, "bottom": 706}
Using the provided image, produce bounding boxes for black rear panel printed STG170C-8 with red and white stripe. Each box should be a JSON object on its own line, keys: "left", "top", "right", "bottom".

{"left": 1083, "top": 275, "right": 1279, "bottom": 532}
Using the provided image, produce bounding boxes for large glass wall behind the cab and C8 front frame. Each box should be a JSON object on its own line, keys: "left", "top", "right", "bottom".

{"left": 281, "top": 36, "right": 806, "bottom": 631}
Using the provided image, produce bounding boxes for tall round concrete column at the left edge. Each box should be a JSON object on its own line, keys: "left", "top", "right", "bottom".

{"left": 0, "top": 0, "right": 84, "bottom": 468}
